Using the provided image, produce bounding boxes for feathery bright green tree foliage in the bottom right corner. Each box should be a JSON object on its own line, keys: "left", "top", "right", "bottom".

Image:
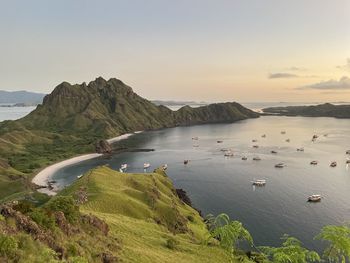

{"left": 315, "top": 225, "right": 350, "bottom": 263}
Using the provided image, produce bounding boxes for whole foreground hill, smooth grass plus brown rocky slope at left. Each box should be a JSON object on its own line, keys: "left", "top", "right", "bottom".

{"left": 0, "top": 167, "right": 238, "bottom": 263}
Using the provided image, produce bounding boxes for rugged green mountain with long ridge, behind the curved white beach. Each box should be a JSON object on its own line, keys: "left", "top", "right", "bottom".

{"left": 0, "top": 78, "right": 258, "bottom": 202}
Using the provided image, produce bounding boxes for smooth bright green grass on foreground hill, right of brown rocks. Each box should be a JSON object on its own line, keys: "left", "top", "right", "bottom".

{"left": 60, "top": 166, "right": 234, "bottom": 263}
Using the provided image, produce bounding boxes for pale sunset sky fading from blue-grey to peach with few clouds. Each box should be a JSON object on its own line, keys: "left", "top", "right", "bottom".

{"left": 0, "top": 0, "right": 350, "bottom": 102}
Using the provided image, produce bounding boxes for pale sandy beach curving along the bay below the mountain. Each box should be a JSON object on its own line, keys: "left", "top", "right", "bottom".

{"left": 32, "top": 131, "right": 141, "bottom": 195}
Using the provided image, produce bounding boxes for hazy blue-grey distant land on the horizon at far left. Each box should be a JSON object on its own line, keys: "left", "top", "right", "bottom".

{"left": 0, "top": 90, "right": 46, "bottom": 106}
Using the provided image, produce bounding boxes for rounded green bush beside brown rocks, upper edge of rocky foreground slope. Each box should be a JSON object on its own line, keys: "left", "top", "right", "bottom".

{"left": 47, "top": 196, "right": 79, "bottom": 223}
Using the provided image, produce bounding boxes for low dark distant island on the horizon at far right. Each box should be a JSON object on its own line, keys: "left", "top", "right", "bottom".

{"left": 262, "top": 103, "right": 350, "bottom": 118}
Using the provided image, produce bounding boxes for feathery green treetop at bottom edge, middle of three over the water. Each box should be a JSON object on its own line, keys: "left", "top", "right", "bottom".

{"left": 260, "top": 235, "right": 321, "bottom": 263}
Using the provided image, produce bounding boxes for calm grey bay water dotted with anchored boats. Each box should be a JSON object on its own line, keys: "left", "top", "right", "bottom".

{"left": 48, "top": 116, "right": 350, "bottom": 252}
